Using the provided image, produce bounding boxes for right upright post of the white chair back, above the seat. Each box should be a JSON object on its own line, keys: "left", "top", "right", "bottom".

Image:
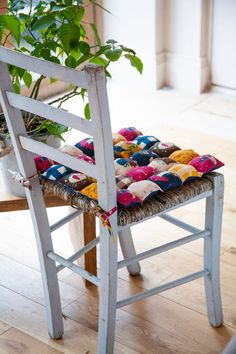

{"left": 84, "top": 64, "right": 116, "bottom": 211}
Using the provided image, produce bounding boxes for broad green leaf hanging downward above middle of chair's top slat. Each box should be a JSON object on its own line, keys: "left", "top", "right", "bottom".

{"left": 59, "top": 23, "right": 80, "bottom": 54}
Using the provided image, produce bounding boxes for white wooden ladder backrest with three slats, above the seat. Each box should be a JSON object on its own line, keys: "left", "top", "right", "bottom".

{"left": 0, "top": 46, "right": 116, "bottom": 211}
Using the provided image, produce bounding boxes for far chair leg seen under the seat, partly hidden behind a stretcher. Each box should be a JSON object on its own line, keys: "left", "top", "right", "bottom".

{"left": 118, "top": 227, "right": 141, "bottom": 276}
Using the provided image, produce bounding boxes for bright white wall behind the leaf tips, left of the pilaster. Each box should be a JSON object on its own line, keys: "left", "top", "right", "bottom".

{"left": 103, "top": 0, "right": 156, "bottom": 89}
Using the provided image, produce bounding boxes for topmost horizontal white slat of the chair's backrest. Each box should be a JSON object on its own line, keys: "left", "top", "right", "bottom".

{"left": 0, "top": 47, "right": 88, "bottom": 89}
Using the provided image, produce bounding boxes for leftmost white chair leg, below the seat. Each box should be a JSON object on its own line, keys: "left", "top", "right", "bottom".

{"left": 26, "top": 180, "right": 64, "bottom": 339}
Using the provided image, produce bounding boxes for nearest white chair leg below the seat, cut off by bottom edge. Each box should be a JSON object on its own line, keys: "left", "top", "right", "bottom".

{"left": 97, "top": 220, "right": 118, "bottom": 354}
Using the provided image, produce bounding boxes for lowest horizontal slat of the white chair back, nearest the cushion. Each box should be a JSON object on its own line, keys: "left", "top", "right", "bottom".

{"left": 19, "top": 136, "right": 97, "bottom": 178}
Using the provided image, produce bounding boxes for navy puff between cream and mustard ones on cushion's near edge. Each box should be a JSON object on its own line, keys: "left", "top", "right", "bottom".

{"left": 148, "top": 171, "right": 182, "bottom": 191}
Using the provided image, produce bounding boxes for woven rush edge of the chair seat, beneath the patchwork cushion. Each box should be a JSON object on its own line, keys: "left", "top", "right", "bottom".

{"left": 40, "top": 173, "right": 215, "bottom": 226}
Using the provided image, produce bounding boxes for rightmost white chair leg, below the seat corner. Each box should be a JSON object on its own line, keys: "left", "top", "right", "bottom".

{"left": 204, "top": 175, "right": 224, "bottom": 327}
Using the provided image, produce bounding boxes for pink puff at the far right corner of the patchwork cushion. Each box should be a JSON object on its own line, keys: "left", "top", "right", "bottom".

{"left": 189, "top": 155, "right": 224, "bottom": 173}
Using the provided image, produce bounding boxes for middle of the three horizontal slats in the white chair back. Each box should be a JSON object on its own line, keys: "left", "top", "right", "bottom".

{"left": 6, "top": 92, "right": 92, "bottom": 135}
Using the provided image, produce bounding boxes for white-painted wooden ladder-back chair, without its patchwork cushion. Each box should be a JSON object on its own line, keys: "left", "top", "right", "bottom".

{"left": 0, "top": 47, "right": 223, "bottom": 354}
